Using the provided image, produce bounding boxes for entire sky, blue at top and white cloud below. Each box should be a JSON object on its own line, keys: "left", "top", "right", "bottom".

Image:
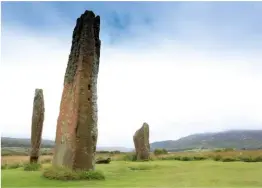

{"left": 0, "top": 2, "right": 262, "bottom": 147}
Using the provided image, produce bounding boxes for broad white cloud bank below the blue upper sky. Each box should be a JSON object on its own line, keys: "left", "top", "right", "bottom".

{"left": 0, "top": 11, "right": 262, "bottom": 147}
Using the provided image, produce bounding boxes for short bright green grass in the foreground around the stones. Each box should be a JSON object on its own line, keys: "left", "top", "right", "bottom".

{"left": 2, "top": 160, "right": 262, "bottom": 188}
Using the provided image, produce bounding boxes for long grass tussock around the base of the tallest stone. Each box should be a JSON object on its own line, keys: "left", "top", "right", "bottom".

{"left": 43, "top": 167, "right": 105, "bottom": 181}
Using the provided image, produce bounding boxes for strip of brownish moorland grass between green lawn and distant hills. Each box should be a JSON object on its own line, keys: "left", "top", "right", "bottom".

{"left": 1, "top": 150, "right": 262, "bottom": 164}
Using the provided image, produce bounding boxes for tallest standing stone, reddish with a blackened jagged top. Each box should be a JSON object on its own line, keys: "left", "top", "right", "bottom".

{"left": 53, "top": 11, "right": 101, "bottom": 170}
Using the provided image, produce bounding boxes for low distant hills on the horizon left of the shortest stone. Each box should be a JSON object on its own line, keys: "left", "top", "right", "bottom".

{"left": 1, "top": 137, "right": 133, "bottom": 152}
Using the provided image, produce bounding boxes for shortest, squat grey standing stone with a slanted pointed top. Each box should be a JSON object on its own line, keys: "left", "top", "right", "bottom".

{"left": 133, "top": 123, "right": 150, "bottom": 160}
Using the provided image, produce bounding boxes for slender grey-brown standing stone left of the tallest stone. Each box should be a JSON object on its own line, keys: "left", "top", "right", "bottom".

{"left": 30, "top": 89, "right": 45, "bottom": 163}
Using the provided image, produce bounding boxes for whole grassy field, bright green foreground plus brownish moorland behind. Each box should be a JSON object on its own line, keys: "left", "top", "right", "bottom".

{"left": 1, "top": 150, "right": 262, "bottom": 188}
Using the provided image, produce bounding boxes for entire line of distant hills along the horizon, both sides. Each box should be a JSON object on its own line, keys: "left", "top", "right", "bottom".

{"left": 1, "top": 130, "right": 262, "bottom": 152}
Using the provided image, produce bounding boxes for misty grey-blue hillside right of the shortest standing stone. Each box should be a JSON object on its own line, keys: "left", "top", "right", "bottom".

{"left": 151, "top": 130, "right": 262, "bottom": 151}
